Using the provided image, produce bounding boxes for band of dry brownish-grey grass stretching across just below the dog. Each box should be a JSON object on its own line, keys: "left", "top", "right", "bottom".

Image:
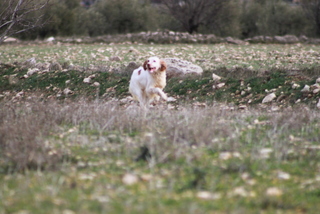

{"left": 0, "top": 97, "right": 320, "bottom": 170}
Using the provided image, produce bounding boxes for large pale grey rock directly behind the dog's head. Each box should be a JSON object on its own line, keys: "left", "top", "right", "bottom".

{"left": 163, "top": 58, "right": 203, "bottom": 78}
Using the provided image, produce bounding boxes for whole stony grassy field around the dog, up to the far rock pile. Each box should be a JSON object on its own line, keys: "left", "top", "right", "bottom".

{"left": 0, "top": 44, "right": 320, "bottom": 214}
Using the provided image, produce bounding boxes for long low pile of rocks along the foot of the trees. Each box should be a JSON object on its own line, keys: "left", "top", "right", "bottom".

{"left": 4, "top": 31, "right": 320, "bottom": 45}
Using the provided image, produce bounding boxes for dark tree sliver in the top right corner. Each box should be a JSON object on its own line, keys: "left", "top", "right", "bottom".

{"left": 300, "top": 0, "right": 320, "bottom": 34}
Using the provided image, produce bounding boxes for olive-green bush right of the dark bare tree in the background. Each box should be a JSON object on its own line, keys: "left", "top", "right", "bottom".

{"left": 241, "top": 0, "right": 311, "bottom": 38}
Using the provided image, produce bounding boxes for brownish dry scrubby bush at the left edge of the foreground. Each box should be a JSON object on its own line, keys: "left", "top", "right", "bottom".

{"left": 0, "top": 100, "right": 63, "bottom": 172}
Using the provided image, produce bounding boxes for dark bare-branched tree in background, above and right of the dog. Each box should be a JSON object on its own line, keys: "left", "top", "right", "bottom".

{"left": 162, "top": 0, "right": 230, "bottom": 33}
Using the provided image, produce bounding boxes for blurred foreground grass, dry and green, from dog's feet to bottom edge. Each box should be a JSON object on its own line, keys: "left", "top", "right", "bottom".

{"left": 0, "top": 99, "right": 320, "bottom": 213}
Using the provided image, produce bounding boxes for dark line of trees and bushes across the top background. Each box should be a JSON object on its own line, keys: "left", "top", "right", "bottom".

{"left": 0, "top": 0, "right": 320, "bottom": 43}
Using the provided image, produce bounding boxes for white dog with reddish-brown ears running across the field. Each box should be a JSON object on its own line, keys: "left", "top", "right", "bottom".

{"left": 129, "top": 57, "right": 167, "bottom": 108}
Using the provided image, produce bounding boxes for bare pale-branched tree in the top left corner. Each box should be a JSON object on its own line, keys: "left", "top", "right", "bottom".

{"left": 0, "top": 0, "right": 50, "bottom": 44}
